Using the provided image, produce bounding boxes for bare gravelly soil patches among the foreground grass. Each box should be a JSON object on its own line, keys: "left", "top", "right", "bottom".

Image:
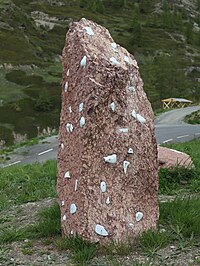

{"left": 0, "top": 197, "right": 200, "bottom": 266}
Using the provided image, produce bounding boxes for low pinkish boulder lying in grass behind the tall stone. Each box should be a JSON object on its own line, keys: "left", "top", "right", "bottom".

{"left": 158, "top": 146, "right": 193, "bottom": 168}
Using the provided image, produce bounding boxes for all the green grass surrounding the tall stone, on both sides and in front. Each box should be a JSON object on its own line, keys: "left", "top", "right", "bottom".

{"left": 0, "top": 140, "right": 200, "bottom": 266}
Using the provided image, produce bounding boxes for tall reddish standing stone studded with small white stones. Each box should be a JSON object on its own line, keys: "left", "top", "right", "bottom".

{"left": 57, "top": 19, "right": 159, "bottom": 242}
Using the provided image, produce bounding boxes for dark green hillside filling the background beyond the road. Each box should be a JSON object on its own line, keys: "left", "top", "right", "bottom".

{"left": 0, "top": 0, "right": 200, "bottom": 145}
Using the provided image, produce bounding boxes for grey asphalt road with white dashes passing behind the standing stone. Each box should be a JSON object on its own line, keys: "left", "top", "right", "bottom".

{"left": 0, "top": 106, "right": 200, "bottom": 168}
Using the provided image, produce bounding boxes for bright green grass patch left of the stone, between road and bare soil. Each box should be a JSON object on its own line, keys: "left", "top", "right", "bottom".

{"left": 0, "top": 160, "right": 57, "bottom": 210}
